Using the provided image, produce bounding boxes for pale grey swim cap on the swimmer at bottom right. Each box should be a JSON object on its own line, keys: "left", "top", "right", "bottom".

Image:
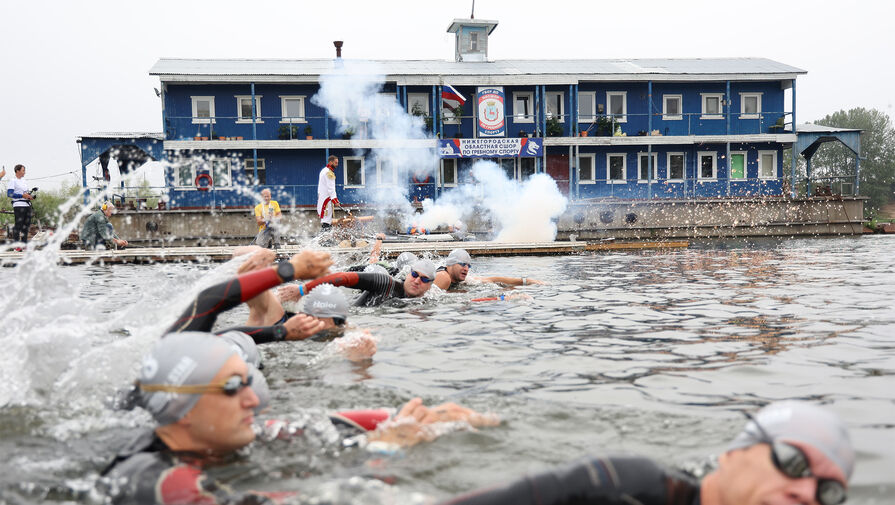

{"left": 728, "top": 401, "right": 855, "bottom": 482}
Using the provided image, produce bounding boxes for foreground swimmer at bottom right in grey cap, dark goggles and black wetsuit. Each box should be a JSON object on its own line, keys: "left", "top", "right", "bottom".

{"left": 442, "top": 401, "right": 855, "bottom": 505}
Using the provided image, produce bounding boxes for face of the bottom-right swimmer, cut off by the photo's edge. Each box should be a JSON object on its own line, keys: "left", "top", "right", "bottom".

{"left": 718, "top": 444, "right": 846, "bottom": 505}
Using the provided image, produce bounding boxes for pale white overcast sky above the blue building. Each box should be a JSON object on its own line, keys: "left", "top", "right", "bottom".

{"left": 0, "top": 0, "right": 895, "bottom": 187}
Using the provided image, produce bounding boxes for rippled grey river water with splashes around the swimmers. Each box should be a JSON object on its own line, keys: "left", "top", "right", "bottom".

{"left": 0, "top": 236, "right": 895, "bottom": 504}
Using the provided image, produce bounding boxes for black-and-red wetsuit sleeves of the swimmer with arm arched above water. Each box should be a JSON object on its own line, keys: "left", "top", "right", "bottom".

{"left": 167, "top": 261, "right": 295, "bottom": 344}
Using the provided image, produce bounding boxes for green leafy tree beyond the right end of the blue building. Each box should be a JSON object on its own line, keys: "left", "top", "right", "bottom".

{"left": 811, "top": 107, "right": 895, "bottom": 216}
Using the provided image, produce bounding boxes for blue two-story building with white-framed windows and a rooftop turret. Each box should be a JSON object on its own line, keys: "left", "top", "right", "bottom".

{"left": 82, "top": 19, "right": 855, "bottom": 238}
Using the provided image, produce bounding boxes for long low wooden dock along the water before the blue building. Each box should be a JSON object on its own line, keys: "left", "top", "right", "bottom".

{"left": 0, "top": 240, "right": 689, "bottom": 266}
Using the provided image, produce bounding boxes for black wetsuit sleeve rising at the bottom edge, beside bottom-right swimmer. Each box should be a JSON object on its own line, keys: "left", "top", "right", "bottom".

{"left": 442, "top": 457, "right": 699, "bottom": 505}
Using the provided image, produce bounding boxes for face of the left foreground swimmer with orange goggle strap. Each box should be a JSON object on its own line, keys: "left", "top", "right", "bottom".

{"left": 177, "top": 355, "right": 259, "bottom": 453}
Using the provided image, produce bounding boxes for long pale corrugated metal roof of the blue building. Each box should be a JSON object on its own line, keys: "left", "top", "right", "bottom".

{"left": 149, "top": 58, "right": 806, "bottom": 78}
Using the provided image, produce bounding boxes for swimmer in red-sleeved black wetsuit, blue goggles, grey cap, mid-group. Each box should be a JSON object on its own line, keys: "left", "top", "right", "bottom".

{"left": 290, "top": 259, "right": 435, "bottom": 307}
